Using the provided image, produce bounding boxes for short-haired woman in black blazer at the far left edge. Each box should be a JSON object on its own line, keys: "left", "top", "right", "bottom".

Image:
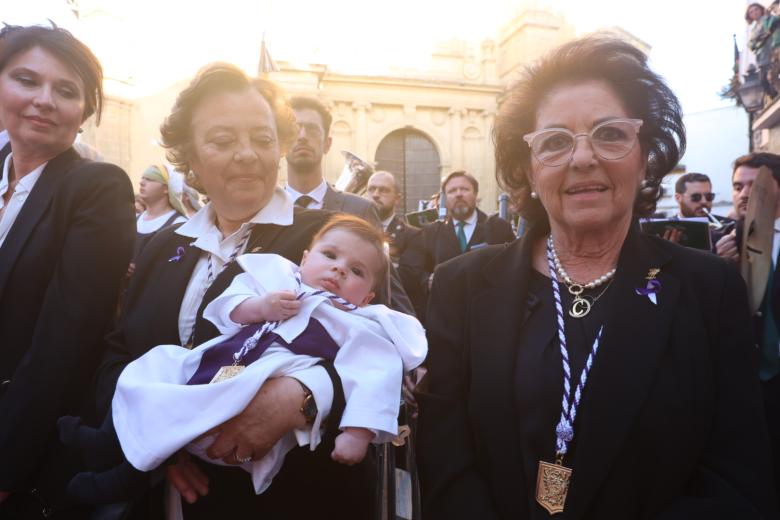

{"left": 0, "top": 26, "right": 134, "bottom": 519}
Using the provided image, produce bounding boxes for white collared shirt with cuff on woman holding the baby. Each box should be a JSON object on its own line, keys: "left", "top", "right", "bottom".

{"left": 171, "top": 187, "right": 333, "bottom": 421}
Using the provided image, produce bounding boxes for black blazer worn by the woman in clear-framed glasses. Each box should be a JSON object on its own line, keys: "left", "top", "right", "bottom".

{"left": 417, "top": 226, "right": 777, "bottom": 520}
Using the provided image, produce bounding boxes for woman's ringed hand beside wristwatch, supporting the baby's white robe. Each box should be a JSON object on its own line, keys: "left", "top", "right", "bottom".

{"left": 206, "top": 377, "right": 306, "bottom": 464}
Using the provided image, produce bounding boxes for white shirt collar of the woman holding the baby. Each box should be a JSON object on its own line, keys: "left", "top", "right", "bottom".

{"left": 176, "top": 187, "right": 293, "bottom": 255}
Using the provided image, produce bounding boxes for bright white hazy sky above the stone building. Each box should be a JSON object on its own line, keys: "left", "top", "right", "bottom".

{"left": 0, "top": 0, "right": 746, "bottom": 113}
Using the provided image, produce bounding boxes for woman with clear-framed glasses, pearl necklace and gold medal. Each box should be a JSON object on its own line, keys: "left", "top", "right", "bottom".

{"left": 417, "top": 37, "right": 777, "bottom": 519}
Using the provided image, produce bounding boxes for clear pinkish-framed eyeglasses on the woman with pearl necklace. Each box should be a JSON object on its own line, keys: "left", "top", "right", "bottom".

{"left": 523, "top": 119, "right": 643, "bottom": 166}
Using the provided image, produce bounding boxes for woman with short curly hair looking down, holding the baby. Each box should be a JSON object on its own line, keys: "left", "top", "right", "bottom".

{"left": 64, "top": 63, "right": 373, "bottom": 520}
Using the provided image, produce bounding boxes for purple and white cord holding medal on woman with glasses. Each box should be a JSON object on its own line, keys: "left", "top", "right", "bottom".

{"left": 547, "top": 235, "right": 604, "bottom": 456}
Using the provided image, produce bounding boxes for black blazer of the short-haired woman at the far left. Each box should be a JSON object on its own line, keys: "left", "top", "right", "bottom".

{"left": 0, "top": 148, "right": 135, "bottom": 491}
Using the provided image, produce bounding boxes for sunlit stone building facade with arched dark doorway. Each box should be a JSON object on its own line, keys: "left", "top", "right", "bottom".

{"left": 77, "top": 9, "right": 649, "bottom": 212}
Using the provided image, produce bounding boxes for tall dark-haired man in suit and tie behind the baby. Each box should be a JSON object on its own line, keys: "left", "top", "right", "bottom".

{"left": 285, "top": 96, "right": 414, "bottom": 314}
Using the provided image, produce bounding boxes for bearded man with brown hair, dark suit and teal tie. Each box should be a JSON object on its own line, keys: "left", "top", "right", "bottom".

{"left": 398, "top": 170, "right": 515, "bottom": 324}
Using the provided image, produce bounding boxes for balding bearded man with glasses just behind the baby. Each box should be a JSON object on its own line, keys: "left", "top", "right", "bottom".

{"left": 365, "top": 170, "right": 417, "bottom": 266}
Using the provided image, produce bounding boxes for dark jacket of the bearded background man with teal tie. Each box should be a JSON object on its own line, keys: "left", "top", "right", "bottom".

{"left": 398, "top": 209, "right": 515, "bottom": 322}
